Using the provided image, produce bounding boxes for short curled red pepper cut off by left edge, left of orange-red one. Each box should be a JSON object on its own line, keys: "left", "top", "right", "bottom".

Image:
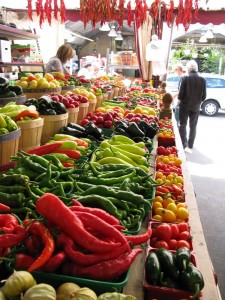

{"left": 0, "top": 225, "right": 27, "bottom": 248}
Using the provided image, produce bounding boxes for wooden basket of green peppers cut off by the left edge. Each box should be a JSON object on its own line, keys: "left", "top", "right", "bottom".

{"left": 0, "top": 128, "right": 21, "bottom": 165}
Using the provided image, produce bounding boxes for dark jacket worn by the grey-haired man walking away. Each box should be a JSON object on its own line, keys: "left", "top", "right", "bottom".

{"left": 178, "top": 72, "right": 206, "bottom": 112}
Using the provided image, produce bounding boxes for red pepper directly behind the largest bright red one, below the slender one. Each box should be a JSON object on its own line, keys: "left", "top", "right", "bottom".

{"left": 74, "top": 211, "right": 130, "bottom": 251}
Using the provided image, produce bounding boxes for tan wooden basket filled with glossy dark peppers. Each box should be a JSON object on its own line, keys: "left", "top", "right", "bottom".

{"left": 41, "top": 113, "right": 68, "bottom": 145}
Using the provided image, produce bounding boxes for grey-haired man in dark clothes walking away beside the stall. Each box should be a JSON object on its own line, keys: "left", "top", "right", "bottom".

{"left": 178, "top": 60, "right": 206, "bottom": 153}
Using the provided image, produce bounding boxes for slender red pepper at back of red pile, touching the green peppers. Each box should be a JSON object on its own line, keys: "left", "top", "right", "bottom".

{"left": 69, "top": 206, "right": 120, "bottom": 225}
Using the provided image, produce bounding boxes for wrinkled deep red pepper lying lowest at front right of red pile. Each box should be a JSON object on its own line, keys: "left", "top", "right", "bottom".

{"left": 68, "top": 249, "right": 143, "bottom": 281}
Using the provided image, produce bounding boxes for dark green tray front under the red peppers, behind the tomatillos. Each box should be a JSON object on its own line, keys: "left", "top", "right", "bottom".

{"left": 32, "top": 271, "right": 129, "bottom": 295}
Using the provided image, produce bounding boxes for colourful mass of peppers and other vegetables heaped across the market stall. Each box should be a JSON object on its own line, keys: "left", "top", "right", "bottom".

{"left": 0, "top": 82, "right": 208, "bottom": 300}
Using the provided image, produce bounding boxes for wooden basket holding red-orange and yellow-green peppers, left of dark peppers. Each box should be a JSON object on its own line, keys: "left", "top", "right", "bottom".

{"left": 17, "top": 118, "right": 44, "bottom": 151}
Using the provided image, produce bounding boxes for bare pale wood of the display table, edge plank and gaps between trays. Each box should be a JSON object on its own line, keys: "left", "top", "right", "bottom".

{"left": 123, "top": 127, "right": 222, "bottom": 300}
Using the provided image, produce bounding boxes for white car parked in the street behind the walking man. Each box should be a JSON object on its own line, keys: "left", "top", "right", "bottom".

{"left": 166, "top": 73, "right": 225, "bottom": 117}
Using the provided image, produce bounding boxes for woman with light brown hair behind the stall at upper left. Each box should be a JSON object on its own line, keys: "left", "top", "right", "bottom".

{"left": 46, "top": 44, "right": 75, "bottom": 74}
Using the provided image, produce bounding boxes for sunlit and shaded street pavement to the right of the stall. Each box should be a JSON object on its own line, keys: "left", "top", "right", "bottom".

{"left": 183, "top": 111, "right": 225, "bottom": 299}
